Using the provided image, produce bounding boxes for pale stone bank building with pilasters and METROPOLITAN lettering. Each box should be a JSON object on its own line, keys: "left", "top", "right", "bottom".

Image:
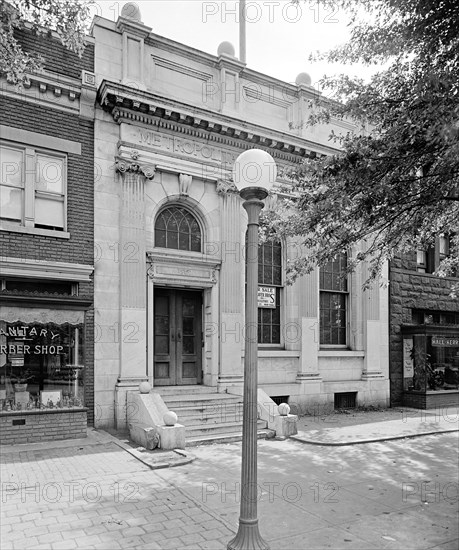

{"left": 92, "top": 6, "right": 389, "bottom": 428}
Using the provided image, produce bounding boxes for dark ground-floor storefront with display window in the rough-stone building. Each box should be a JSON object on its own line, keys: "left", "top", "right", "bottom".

{"left": 401, "top": 324, "right": 459, "bottom": 409}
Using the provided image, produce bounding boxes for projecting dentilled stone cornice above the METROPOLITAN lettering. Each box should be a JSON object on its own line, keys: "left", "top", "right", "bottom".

{"left": 98, "top": 80, "right": 338, "bottom": 162}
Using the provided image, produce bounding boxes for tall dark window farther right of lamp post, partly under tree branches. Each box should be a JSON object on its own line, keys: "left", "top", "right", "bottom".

{"left": 320, "top": 254, "right": 349, "bottom": 347}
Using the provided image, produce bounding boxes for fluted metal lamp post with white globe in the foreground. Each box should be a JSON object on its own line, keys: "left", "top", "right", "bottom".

{"left": 227, "top": 149, "right": 277, "bottom": 550}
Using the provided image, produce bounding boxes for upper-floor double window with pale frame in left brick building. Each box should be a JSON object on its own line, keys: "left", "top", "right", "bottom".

{"left": 0, "top": 141, "right": 67, "bottom": 231}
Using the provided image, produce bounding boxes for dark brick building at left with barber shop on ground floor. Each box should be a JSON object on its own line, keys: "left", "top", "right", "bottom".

{"left": 0, "top": 25, "right": 95, "bottom": 443}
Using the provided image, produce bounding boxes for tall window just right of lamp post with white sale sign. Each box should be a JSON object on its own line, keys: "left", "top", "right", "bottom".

{"left": 258, "top": 241, "right": 282, "bottom": 345}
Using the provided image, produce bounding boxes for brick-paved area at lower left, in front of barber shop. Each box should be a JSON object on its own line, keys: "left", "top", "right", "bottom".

{"left": 0, "top": 432, "right": 232, "bottom": 550}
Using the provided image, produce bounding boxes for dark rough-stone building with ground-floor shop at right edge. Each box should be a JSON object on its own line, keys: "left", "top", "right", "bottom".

{"left": 390, "top": 246, "right": 459, "bottom": 408}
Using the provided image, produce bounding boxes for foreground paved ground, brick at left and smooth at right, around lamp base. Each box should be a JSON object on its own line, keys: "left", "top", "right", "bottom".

{"left": 1, "top": 432, "right": 458, "bottom": 550}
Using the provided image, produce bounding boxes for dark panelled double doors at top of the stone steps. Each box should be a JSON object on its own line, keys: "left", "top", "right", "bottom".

{"left": 154, "top": 288, "right": 202, "bottom": 386}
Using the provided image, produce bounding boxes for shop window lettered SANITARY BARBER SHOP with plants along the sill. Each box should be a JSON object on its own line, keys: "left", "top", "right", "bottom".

{"left": 0, "top": 321, "right": 84, "bottom": 412}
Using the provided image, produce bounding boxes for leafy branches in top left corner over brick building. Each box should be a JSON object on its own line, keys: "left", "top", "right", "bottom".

{"left": 0, "top": 0, "right": 93, "bottom": 84}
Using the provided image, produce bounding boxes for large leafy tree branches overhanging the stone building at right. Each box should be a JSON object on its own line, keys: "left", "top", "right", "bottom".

{"left": 272, "top": 0, "right": 459, "bottom": 294}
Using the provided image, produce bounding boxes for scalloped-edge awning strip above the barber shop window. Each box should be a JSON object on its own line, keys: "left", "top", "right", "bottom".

{"left": 0, "top": 306, "right": 84, "bottom": 325}
